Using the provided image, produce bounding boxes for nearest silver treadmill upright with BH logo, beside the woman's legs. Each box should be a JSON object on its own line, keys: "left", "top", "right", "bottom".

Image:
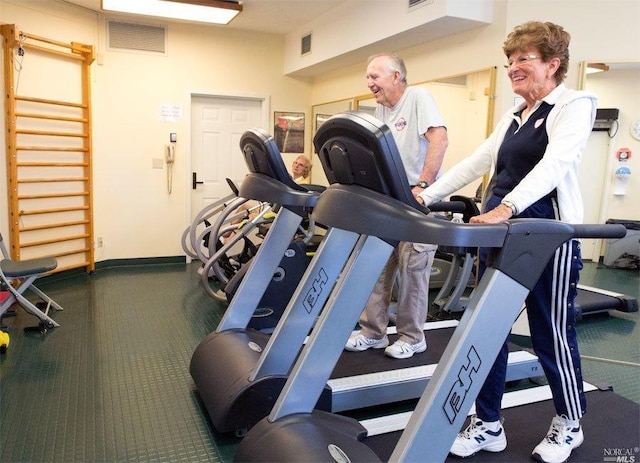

{"left": 391, "top": 268, "right": 529, "bottom": 461}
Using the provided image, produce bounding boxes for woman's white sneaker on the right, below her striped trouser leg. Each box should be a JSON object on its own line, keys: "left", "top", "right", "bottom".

{"left": 531, "top": 416, "right": 584, "bottom": 463}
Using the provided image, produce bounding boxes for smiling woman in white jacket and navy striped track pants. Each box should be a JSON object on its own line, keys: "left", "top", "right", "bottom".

{"left": 418, "top": 22, "right": 597, "bottom": 462}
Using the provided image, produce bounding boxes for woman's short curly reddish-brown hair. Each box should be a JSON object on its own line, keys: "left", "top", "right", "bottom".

{"left": 502, "top": 21, "right": 571, "bottom": 84}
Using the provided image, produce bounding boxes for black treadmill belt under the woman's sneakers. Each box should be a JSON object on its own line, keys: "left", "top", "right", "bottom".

{"left": 366, "top": 390, "right": 640, "bottom": 463}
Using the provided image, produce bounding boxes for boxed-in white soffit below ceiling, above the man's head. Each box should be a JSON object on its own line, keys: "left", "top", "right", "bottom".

{"left": 284, "top": 0, "right": 492, "bottom": 75}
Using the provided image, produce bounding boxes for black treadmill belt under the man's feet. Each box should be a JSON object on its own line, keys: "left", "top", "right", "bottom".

{"left": 331, "top": 328, "right": 522, "bottom": 379}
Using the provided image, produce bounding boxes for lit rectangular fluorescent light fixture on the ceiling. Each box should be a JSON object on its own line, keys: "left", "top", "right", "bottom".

{"left": 102, "top": 0, "right": 242, "bottom": 24}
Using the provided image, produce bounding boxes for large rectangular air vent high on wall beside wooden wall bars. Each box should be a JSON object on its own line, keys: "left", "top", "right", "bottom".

{"left": 107, "top": 21, "right": 167, "bottom": 55}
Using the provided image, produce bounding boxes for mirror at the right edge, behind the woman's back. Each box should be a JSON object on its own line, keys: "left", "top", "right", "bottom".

{"left": 578, "top": 60, "right": 640, "bottom": 262}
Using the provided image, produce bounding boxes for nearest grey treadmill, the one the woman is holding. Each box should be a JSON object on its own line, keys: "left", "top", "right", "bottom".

{"left": 235, "top": 113, "right": 638, "bottom": 462}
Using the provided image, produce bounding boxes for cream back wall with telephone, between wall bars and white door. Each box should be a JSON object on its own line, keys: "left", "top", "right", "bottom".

{"left": 0, "top": 0, "right": 310, "bottom": 261}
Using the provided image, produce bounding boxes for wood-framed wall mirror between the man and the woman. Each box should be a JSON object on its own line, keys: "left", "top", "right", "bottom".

{"left": 355, "top": 67, "right": 496, "bottom": 197}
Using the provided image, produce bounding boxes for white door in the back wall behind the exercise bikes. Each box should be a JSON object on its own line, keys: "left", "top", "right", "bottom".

{"left": 191, "top": 96, "right": 267, "bottom": 220}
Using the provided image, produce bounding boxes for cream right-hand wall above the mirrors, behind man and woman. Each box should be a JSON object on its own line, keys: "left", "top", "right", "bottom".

{"left": 312, "top": 0, "right": 640, "bottom": 246}
